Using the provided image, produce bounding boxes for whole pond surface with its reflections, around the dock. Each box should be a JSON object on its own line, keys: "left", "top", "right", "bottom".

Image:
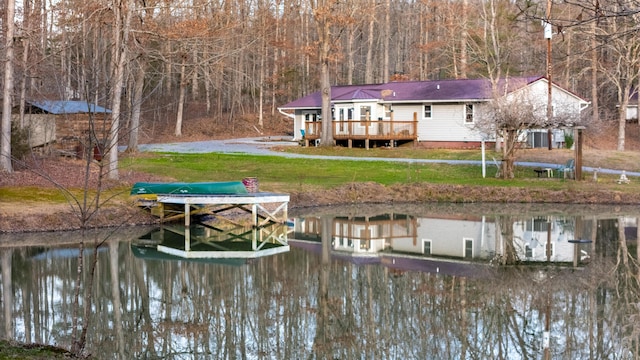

{"left": 0, "top": 204, "right": 640, "bottom": 359}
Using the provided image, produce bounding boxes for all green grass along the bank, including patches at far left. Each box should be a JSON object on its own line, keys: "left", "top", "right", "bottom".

{"left": 0, "top": 147, "right": 640, "bottom": 203}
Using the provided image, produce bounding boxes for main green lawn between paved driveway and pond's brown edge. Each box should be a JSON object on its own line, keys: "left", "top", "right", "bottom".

{"left": 121, "top": 149, "right": 640, "bottom": 192}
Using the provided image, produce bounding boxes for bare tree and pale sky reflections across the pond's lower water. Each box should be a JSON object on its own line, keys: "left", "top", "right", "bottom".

{"left": 2, "top": 219, "right": 640, "bottom": 359}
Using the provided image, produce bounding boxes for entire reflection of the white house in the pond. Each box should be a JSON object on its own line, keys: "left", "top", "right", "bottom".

{"left": 293, "top": 213, "right": 608, "bottom": 263}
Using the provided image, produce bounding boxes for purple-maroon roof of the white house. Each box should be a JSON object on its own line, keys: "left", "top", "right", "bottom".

{"left": 281, "top": 76, "right": 564, "bottom": 109}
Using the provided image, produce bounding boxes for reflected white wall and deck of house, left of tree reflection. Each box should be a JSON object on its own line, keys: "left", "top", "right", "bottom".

{"left": 293, "top": 214, "right": 496, "bottom": 260}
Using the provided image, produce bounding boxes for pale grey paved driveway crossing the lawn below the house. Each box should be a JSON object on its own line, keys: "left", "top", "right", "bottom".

{"left": 131, "top": 137, "right": 640, "bottom": 177}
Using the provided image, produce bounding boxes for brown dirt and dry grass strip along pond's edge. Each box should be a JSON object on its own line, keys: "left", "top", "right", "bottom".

{"left": 0, "top": 183, "right": 640, "bottom": 233}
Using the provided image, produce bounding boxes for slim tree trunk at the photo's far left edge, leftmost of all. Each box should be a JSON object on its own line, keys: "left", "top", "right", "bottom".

{"left": 0, "top": 0, "right": 16, "bottom": 172}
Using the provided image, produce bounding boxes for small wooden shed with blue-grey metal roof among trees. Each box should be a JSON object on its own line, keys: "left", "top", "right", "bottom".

{"left": 14, "top": 100, "right": 111, "bottom": 155}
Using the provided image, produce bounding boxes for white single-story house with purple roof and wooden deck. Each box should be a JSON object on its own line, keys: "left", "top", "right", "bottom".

{"left": 278, "top": 76, "right": 589, "bottom": 148}
